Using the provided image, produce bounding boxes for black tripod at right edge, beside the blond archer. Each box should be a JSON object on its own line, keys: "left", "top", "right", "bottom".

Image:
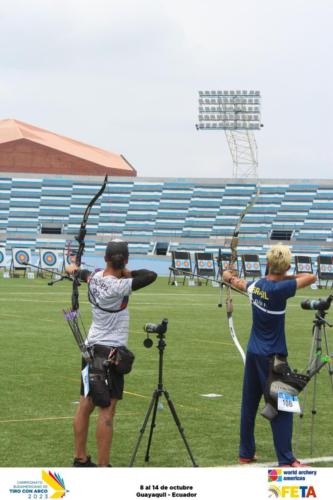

{"left": 296, "top": 309, "right": 333, "bottom": 456}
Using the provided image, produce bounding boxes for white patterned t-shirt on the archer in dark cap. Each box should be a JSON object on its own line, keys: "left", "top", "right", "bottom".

{"left": 87, "top": 271, "right": 133, "bottom": 346}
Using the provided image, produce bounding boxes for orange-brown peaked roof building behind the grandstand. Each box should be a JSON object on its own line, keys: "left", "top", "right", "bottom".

{"left": 0, "top": 119, "right": 136, "bottom": 176}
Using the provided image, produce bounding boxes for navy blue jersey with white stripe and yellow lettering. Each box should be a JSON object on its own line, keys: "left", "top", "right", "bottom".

{"left": 247, "top": 278, "right": 296, "bottom": 356}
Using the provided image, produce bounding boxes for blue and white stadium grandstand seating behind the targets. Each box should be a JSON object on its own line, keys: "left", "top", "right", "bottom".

{"left": 0, "top": 172, "right": 333, "bottom": 274}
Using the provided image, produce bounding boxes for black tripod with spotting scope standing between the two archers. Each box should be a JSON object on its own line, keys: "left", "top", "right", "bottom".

{"left": 129, "top": 323, "right": 198, "bottom": 467}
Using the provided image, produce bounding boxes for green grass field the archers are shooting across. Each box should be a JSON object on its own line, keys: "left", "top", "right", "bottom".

{"left": 0, "top": 278, "right": 333, "bottom": 467}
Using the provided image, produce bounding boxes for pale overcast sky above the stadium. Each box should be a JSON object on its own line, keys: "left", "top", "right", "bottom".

{"left": 0, "top": 0, "right": 333, "bottom": 179}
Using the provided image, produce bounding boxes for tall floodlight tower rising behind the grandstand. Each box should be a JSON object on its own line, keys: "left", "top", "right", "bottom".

{"left": 196, "top": 90, "right": 262, "bottom": 179}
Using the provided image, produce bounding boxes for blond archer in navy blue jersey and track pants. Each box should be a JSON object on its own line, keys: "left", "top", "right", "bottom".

{"left": 223, "top": 244, "right": 316, "bottom": 467}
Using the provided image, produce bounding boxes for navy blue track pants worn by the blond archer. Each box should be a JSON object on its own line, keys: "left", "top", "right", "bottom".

{"left": 239, "top": 352, "right": 295, "bottom": 465}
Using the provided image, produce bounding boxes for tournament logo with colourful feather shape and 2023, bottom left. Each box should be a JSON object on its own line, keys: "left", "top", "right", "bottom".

{"left": 9, "top": 470, "right": 68, "bottom": 500}
